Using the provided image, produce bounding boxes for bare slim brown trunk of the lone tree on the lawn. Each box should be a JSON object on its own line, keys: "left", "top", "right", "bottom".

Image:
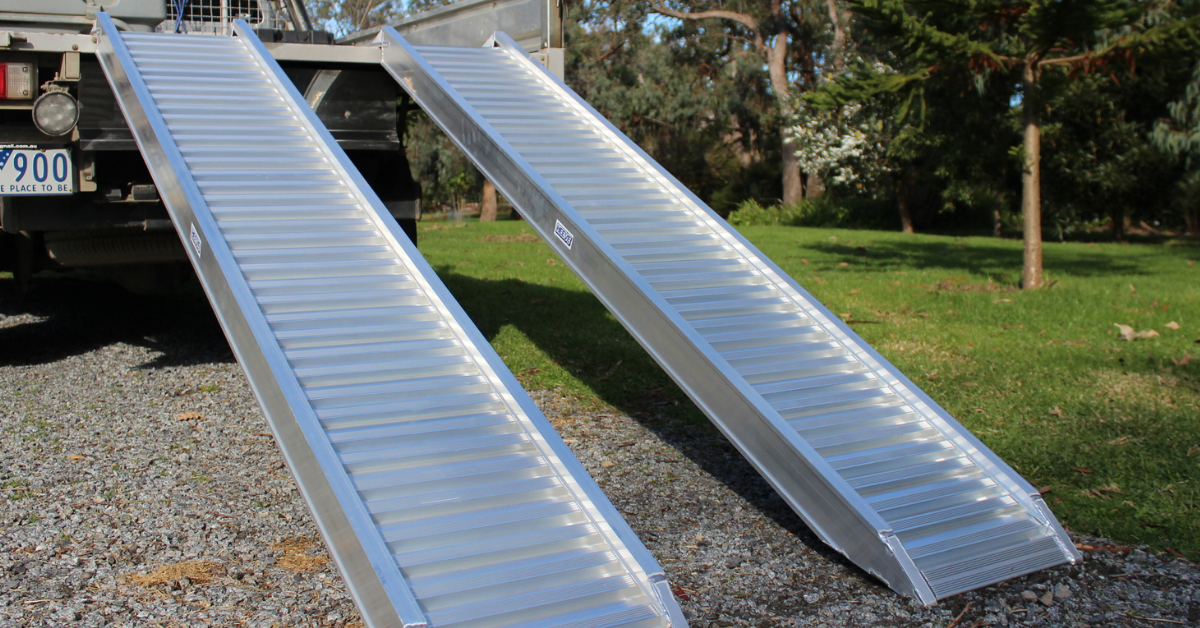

{"left": 1021, "top": 59, "right": 1044, "bottom": 289}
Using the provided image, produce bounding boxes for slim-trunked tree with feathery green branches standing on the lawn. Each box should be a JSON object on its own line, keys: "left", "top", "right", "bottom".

{"left": 852, "top": 0, "right": 1200, "bottom": 288}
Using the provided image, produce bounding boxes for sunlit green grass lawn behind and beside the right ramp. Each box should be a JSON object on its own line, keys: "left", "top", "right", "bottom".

{"left": 421, "top": 222, "right": 1200, "bottom": 560}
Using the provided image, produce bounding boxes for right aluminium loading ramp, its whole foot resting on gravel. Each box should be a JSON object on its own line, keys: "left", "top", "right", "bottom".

{"left": 380, "top": 30, "right": 1079, "bottom": 604}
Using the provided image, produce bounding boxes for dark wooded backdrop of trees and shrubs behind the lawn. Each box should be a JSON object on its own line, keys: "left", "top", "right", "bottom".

{"left": 310, "top": 0, "right": 1200, "bottom": 239}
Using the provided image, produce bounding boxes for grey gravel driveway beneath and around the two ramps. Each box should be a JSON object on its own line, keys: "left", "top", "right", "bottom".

{"left": 0, "top": 277, "right": 1200, "bottom": 628}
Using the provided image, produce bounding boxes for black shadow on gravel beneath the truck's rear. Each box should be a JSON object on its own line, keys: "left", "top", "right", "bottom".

{"left": 0, "top": 271, "right": 234, "bottom": 369}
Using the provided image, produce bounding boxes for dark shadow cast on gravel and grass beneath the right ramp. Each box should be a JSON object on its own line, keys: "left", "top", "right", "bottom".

{"left": 438, "top": 268, "right": 868, "bottom": 578}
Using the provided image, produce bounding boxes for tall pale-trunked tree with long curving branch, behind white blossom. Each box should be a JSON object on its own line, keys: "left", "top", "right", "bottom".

{"left": 654, "top": 0, "right": 846, "bottom": 204}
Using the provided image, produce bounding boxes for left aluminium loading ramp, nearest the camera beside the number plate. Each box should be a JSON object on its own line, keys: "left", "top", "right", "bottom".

{"left": 96, "top": 13, "right": 684, "bottom": 628}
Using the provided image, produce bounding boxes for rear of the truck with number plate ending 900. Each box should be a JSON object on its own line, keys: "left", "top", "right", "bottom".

{"left": 0, "top": 0, "right": 429, "bottom": 292}
